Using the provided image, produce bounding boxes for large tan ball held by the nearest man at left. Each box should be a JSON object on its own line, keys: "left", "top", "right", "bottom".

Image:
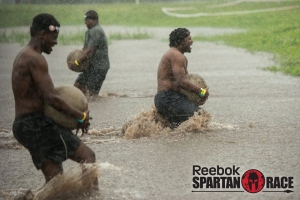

{"left": 44, "top": 86, "right": 88, "bottom": 130}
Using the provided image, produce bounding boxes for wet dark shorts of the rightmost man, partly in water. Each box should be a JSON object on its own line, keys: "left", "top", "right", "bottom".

{"left": 154, "top": 90, "right": 199, "bottom": 124}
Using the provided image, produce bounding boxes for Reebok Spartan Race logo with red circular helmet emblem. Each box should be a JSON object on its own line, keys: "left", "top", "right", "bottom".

{"left": 192, "top": 165, "right": 294, "bottom": 193}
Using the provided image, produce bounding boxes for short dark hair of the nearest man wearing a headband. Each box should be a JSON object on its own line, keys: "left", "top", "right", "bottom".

{"left": 30, "top": 13, "right": 60, "bottom": 36}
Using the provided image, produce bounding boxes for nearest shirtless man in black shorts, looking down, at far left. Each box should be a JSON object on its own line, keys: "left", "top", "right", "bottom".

{"left": 11, "top": 13, "right": 97, "bottom": 187}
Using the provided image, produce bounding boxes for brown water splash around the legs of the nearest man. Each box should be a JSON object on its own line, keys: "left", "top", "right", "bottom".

{"left": 0, "top": 162, "right": 121, "bottom": 200}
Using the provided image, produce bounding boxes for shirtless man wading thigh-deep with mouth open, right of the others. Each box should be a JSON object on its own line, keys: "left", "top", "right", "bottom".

{"left": 154, "top": 28, "right": 209, "bottom": 127}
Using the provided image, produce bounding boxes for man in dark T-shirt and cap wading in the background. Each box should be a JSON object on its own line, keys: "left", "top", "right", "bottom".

{"left": 71, "top": 10, "right": 110, "bottom": 96}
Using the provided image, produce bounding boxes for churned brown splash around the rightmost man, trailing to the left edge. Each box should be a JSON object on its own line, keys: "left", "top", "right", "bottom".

{"left": 0, "top": 109, "right": 239, "bottom": 149}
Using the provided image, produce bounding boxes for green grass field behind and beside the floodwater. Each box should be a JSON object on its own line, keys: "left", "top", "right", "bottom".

{"left": 0, "top": 0, "right": 300, "bottom": 76}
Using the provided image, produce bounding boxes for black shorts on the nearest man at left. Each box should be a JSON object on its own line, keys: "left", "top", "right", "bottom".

{"left": 13, "top": 112, "right": 81, "bottom": 169}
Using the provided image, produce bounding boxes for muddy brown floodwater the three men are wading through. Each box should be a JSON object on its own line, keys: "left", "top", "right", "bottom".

{"left": 0, "top": 25, "right": 300, "bottom": 199}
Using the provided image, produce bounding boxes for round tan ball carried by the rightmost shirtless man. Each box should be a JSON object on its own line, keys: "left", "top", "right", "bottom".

{"left": 180, "top": 74, "right": 207, "bottom": 105}
